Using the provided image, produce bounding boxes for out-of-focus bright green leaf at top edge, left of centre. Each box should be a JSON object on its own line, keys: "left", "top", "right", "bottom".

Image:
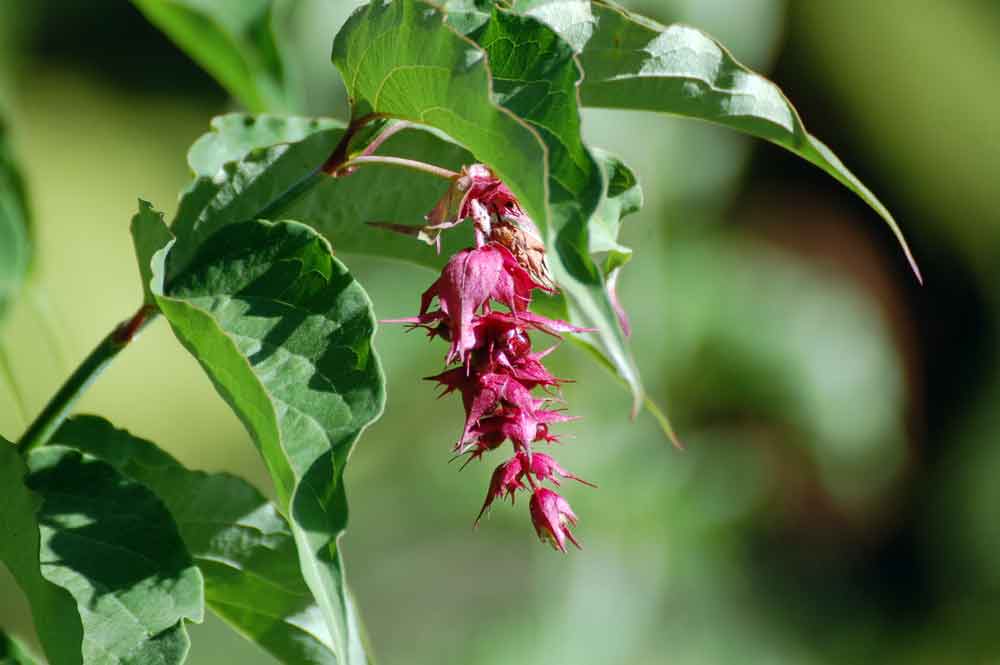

{"left": 132, "top": 0, "right": 300, "bottom": 112}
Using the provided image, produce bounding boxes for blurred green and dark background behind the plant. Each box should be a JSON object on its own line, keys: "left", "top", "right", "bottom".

{"left": 0, "top": 0, "right": 1000, "bottom": 665}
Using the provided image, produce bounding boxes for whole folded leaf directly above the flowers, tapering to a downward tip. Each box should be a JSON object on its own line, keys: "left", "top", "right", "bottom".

{"left": 333, "top": 0, "right": 642, "bottom": 416}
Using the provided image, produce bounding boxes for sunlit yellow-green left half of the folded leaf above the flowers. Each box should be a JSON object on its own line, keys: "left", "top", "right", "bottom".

{"left": 333, "top": 0, "right": 547, "bottom": 223}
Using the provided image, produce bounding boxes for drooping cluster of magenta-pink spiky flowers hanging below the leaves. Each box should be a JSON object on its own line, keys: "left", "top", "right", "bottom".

{"left": 393, "top": 164, "right": 590, "bottom": 552}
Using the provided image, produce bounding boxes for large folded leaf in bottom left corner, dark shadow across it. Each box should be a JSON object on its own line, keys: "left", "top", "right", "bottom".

{"left": 0, "top": 441, "right": 203, "bottom": 665}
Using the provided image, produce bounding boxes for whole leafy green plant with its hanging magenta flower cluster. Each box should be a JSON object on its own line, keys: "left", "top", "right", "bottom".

{"left": 0, "top": 0, "right": 919, "bottom": 665}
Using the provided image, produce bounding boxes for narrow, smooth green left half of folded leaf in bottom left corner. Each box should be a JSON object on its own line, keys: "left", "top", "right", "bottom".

{"left": 0, "top": 437, "right": 84, "bottom": 665}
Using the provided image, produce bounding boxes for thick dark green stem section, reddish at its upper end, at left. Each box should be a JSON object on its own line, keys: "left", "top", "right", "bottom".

{"left": 17, "top": 305, "right": 157, "bottom": 455}
